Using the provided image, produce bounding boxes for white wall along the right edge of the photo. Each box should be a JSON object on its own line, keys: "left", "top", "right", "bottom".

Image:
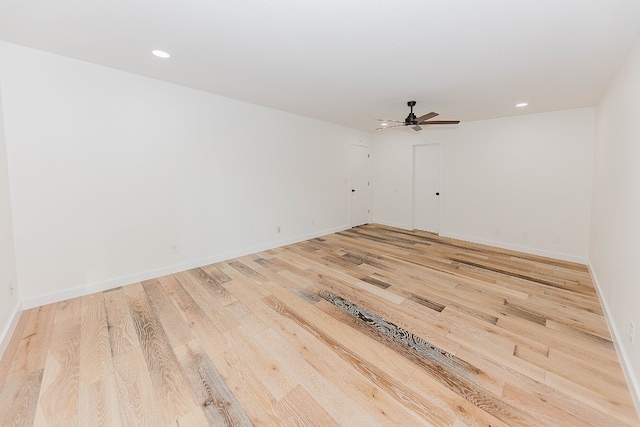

{"left": 589, "top": 38, "right": 640, "bottom": 411}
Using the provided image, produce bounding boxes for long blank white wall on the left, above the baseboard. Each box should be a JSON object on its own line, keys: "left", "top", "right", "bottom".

{"left": 0, "top": 43, "right": 370, "bottom": 307}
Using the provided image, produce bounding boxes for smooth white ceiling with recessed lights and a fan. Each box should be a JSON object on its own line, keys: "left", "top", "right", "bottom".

{"left": 0, "top": 0, "right": 640, "bottom": 130}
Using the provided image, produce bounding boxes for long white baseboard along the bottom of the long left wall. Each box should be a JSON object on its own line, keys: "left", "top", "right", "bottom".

{"left": 22, "top": 225, "right": 350, "bottom": 310}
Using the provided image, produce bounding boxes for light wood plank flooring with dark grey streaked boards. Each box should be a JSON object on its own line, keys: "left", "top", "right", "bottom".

{"left": 0, "top": 225, "right": 640, "bottom": 427}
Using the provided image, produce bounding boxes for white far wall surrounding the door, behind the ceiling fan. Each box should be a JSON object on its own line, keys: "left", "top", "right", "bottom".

{"left": 373, "top": 108, "right": 595, "bottom": 263}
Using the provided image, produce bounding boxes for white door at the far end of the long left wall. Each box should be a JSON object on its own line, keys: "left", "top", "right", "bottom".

{"left": 349, "top": 145, "right": 371, "bottom": 227}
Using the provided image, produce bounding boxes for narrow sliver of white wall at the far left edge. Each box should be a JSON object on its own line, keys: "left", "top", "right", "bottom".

{"left": 0, "top": 66, "right": 19, "bottom": 357}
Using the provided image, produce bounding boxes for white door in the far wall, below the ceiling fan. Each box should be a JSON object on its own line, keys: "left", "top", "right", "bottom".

{"left": 413, "top": 144, "right": 440, "bottom": 233}
